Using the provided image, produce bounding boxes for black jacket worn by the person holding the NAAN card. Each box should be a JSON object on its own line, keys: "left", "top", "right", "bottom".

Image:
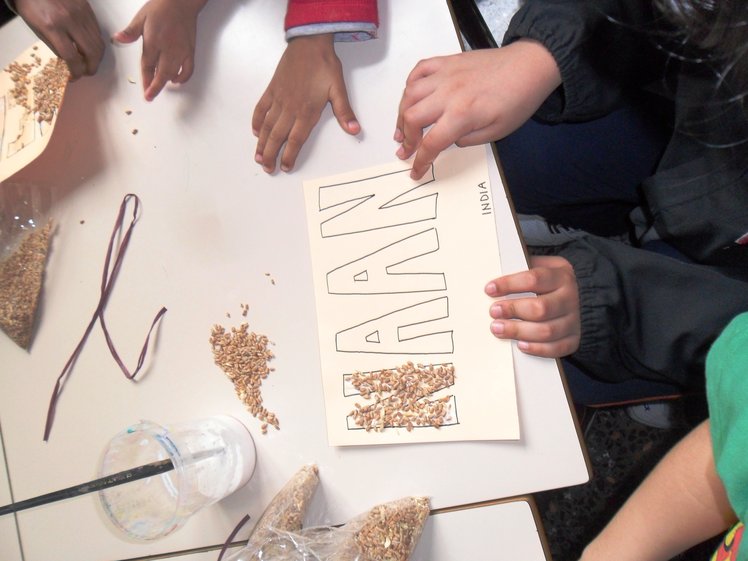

{"left": 504, "top": 0, "right": 748, "bottom": 387}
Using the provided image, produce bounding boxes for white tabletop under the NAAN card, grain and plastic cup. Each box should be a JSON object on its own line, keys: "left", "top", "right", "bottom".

{"left": 0, "top": 0, "right": 589, "bottom": 561}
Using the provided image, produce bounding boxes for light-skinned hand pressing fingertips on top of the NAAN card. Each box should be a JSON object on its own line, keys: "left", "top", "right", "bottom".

{"left": 394, "top": 39, "right": 561, "bottom": 179}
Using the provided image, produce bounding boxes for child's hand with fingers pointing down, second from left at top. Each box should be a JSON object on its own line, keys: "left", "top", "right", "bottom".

{"left": 112, "top": 0, "right": 207, "bottom": 101}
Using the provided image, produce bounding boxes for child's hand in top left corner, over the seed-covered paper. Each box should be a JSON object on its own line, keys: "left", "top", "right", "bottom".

{"left": 16, "top": 0, "right": 104, "bottom": 80}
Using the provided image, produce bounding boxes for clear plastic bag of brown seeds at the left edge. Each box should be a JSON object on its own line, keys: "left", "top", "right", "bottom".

{"left": 0, "top": 181, "right": 53, "bottom": 349}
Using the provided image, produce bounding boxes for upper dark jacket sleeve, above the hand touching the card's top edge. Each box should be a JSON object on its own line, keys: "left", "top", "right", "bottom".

{"left": 503, "top": 0, "right": 664, "bottom": 122}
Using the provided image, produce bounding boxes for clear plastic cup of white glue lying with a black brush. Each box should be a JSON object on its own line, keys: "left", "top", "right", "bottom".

{"left": 99, "top": 416, "right": 255, "bottom": 541}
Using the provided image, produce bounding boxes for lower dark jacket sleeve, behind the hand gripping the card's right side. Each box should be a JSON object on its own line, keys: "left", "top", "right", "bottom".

{"left": 557, "top": 236, "right": 748, "bottom": 389}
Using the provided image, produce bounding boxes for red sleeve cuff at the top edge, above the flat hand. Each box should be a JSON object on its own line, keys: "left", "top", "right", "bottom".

{"left": 285, "top": 0, "right": 379, "bottom": 30}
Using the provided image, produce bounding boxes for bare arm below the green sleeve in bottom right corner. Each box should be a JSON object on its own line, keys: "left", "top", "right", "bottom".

{"left": 582, "top": 421, "right": 736, "bottom": 561}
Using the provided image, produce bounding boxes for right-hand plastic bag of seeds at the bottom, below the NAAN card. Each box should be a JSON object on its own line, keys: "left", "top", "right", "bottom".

{"left": 231, "top": 497, "right": 430, "bottom": 561}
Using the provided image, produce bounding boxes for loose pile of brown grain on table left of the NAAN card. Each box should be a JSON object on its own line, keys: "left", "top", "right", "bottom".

{"left": 210, "top": 322, "right": 280, "bottom": 434}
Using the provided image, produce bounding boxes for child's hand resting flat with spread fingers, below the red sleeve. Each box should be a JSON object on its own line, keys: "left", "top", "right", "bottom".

{"left": 252, "top": 34, "right": 361, "bottom": 173}
